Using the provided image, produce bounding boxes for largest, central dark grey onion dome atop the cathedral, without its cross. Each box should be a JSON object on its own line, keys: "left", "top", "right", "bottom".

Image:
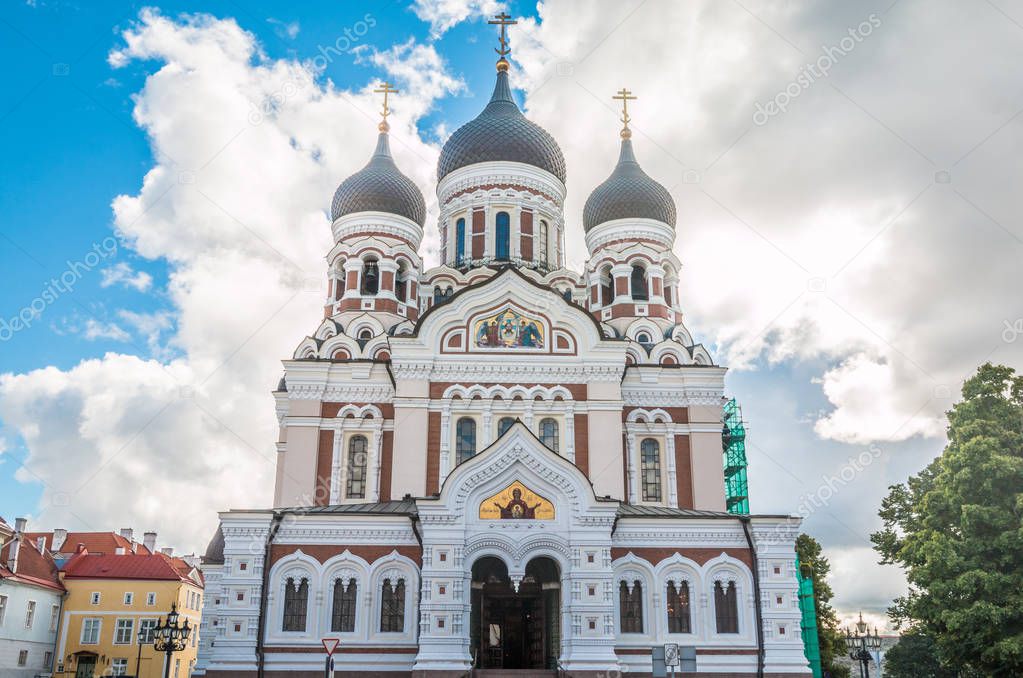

{"left": 437, "top": 70, "right": 565, "bottom": 183}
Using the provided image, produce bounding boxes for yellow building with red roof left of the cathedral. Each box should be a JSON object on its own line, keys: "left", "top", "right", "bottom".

{"left": 53, "top": 546, "right": 203, "bottom": 678}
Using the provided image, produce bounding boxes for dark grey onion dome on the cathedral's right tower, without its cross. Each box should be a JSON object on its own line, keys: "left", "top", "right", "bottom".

{"left": 582, "top": 138, "right": 675, "bottom": 231}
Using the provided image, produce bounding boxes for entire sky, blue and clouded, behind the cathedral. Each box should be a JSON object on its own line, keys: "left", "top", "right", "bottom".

{"left": 0, "top": 0, "right": 1023, "bottom": 625}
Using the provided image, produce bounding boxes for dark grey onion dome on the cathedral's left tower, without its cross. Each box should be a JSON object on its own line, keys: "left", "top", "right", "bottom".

{"left": 330, "top": 131, "right": 427, "bottom": 226}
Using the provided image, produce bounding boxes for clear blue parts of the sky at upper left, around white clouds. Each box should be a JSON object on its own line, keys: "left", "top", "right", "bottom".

{"left": 0, "top": 0, "right": 530, "bottom": 515}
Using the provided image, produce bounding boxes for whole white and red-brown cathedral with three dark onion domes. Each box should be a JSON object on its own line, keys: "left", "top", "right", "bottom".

{"left": 196, "top": 19, "right": 809, "bottom": 678}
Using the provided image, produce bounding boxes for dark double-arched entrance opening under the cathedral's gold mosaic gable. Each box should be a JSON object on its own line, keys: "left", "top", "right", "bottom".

{"left": 470, "top": 556, "right": 562, "bottom": 669}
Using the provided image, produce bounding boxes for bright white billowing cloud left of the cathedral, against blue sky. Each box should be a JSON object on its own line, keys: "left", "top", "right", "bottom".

{"left": 0, "top": 10, "right": 455, "bottom": 549}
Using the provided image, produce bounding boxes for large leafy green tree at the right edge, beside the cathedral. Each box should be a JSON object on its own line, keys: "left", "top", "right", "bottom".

{"left": 871, "top": 363, "right": 1023, "bottom": 677}
